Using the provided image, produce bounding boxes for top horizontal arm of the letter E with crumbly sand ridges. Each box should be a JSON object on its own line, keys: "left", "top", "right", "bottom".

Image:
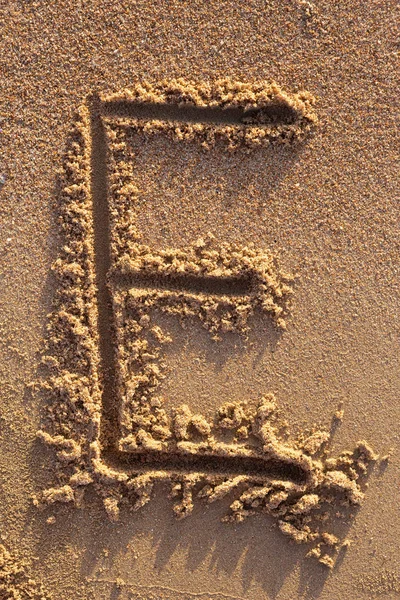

{"left": 102, "top": 78, "right": 318, "bottom": 150}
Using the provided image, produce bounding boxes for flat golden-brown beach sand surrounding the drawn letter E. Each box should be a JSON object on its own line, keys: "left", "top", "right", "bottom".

{"left": 0, "top": 0, "right": 400, "bottom": 600}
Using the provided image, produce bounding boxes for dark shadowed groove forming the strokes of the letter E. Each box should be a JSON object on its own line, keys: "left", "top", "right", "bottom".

{"left": 89, "top": 95, "right": 305, "bottom": 492}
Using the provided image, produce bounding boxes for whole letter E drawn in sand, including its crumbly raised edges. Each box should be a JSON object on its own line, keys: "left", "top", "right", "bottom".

{"left": 36, "top": 80, "right": 374, "bottom": 566}
